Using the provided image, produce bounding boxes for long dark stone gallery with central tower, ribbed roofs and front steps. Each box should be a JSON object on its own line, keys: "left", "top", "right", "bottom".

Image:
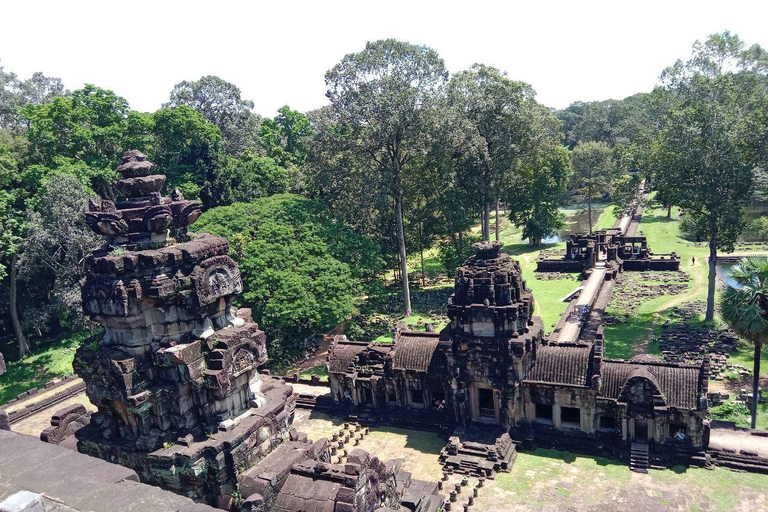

{"left": 328, "top": 242, "right": 708, "bottom": 475}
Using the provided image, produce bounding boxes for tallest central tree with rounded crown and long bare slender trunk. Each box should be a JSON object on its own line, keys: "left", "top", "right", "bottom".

{"left": 325, "top": 39, "right": 448, "bottom": 316}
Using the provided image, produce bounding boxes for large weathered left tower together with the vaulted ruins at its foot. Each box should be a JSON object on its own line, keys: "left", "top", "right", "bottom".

{"left": 41, "top": 150, "right": 442, "bottom": 512}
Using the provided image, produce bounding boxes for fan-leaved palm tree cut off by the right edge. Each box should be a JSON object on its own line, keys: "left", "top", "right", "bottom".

{"left": 722, "top": 257, "right": 768, "bottom": 428}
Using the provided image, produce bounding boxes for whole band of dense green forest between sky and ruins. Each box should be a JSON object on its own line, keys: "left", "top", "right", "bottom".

{"left": 0, "top": 32, "right": 768, "bottom": 368}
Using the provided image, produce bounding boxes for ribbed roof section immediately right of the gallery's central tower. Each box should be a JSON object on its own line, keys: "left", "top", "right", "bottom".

{"left": 525, "top": 345, "right": 591, "bottom": 386}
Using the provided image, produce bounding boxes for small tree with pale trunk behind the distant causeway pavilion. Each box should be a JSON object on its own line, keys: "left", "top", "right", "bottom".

{"left": 571, "top": 142, "right": 614, "bottom": 229}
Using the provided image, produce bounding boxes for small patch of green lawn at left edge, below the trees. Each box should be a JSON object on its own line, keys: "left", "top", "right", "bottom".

{"left": 0, "top": 331, "right": 90, "bottom": 405}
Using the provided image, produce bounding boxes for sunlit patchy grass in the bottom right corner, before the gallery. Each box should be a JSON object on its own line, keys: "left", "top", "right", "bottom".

{"left": 477, "top": 449, "right": 768, "bottom": 512}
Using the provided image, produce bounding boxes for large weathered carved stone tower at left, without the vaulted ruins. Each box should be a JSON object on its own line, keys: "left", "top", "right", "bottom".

{"left": 74, "top": 151, "right": 294, "bottom": 504}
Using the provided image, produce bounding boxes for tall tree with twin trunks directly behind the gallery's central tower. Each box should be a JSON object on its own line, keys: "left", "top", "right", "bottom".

{"left": 447, "top": 64, "right": 559, "bottom": 240}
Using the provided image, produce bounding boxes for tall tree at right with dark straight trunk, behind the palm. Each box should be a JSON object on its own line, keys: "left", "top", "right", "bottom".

{"left": 656, "top": 32, "right": 760, "bottom": 321}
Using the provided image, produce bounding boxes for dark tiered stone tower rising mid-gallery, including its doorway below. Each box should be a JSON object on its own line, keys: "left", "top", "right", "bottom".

{"left": 444, "top": 242, "right": 542, "bottom": 428}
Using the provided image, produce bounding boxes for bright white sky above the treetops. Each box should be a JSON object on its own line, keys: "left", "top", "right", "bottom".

{"left": 0, "top": 0, "right": 768, "bottom": 117}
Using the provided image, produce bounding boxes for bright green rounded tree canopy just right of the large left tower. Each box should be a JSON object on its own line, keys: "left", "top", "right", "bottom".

{"left": 196, "top": 194, "right": 383, "bottom": 363}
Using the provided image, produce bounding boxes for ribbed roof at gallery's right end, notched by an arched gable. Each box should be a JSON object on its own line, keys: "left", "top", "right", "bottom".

{"left": 600, "top": 360, "right": 700, "bottom": 409}
